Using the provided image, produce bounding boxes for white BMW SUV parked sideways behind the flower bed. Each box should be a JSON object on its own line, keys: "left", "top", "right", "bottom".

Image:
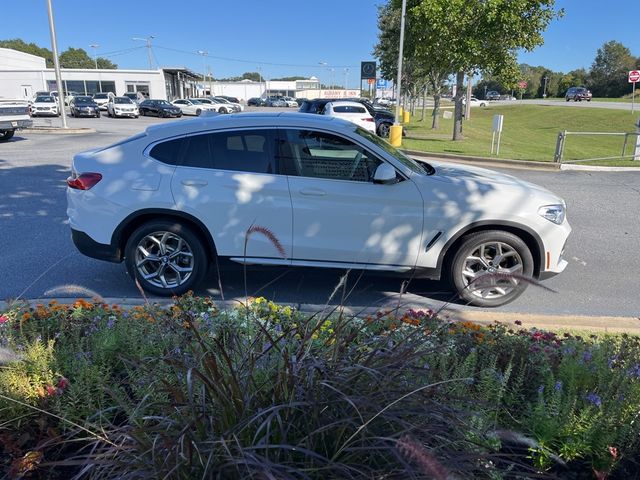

{"left": 67, "top": 112, "right": 571, "bottom": 306}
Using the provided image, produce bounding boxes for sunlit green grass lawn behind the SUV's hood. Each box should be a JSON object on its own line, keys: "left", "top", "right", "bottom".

{"left": 402, "top": 105, "right": 640, "bottom": 167}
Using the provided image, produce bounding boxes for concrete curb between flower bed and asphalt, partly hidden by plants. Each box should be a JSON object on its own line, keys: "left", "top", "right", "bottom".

{"left": 0, "top": 297, "right": 640, "bottom": 335}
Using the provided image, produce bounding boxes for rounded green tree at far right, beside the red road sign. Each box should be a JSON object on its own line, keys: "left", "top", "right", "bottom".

{"left": 588, "top": 40, "right": 636, "bottom": 97}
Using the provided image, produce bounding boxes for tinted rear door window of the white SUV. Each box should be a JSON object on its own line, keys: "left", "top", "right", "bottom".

{"left": 181, "top": 130, "right": 276, "bottom": 173}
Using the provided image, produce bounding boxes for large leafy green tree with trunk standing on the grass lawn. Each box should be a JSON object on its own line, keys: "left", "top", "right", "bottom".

{"left": 380, "top": 0, "right": 562, "bottom": 140}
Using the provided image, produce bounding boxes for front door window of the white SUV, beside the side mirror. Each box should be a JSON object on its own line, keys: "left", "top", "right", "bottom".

{"left": 279, "top": 129, "right": 381, "bottom": 182}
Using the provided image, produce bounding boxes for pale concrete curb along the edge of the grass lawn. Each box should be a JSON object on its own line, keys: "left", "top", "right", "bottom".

{"left": 401, "top": 149, "right": 640, "bottom": 172}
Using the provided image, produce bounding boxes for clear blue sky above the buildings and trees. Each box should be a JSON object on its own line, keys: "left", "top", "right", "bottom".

{"left": 0, "top": 0, "right": 640, "bottom": 84}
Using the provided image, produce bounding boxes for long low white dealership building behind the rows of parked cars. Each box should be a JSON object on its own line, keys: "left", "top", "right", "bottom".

{"left": 0, "top": 48, "right": 360, "bottom": 102}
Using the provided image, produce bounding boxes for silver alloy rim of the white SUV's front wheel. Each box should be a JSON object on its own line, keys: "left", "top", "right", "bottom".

{"left": 462, "top": 241, "right": 524, "bottom": 300}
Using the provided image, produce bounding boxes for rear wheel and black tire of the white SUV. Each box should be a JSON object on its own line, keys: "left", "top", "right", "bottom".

{"left": 125, "top": 220, "right": 209, "bottom": 296}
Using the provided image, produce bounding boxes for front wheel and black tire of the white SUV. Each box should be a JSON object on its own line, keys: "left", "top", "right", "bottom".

{"left": 448, "top": 230, "right": 534, "bottom": 307}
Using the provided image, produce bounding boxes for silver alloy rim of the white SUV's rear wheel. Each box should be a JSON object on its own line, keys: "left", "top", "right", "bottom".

{"left": 135, "top": 231, "right": 195, "bottom": 289}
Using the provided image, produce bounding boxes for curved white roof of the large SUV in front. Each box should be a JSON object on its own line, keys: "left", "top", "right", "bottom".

{"left": 146, "top": 112, "right": 356, "bottom": 140}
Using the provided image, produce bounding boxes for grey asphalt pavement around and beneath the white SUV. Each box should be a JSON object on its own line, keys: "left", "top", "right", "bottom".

{"left": 0, "top": 110, "right": 640, "bottom": 316}
